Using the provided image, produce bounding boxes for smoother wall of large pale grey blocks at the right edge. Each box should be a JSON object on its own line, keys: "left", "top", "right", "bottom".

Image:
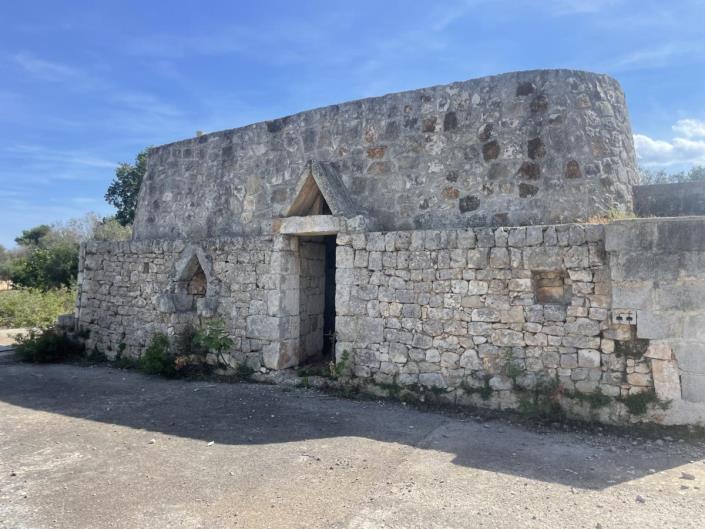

{"left": 606, "top": 217, "right": 705, "bottom": 407}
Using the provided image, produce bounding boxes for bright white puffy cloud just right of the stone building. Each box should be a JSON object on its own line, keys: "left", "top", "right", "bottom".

{"left": 634, "top": 119, "right": 705, "bottom": 167}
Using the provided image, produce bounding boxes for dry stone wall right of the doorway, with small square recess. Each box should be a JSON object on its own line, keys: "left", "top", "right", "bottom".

{"left": 336, "top": 225, "right": 653, "bottom": 420}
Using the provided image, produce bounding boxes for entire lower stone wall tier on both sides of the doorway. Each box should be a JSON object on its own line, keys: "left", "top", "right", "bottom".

{"left": 77, "top": 218, "right": 705, "bottom": 424}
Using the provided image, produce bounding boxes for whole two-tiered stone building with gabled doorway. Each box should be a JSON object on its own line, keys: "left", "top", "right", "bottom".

{"left": 77, "top": 70, "right": 705, "bottom": 423}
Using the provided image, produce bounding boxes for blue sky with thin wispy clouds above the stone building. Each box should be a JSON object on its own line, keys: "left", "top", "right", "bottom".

{"left": 0, "top": 0, "right": 705, "bottom": 246}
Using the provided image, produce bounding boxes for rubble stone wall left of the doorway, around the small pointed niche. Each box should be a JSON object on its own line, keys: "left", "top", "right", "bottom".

{"left": 77, "top": 237, "right": 278, "bottom": 368}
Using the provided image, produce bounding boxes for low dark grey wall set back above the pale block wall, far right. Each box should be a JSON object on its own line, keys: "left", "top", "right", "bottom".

{"left": 633, "top": 182, "right": 705, "bottom": 217}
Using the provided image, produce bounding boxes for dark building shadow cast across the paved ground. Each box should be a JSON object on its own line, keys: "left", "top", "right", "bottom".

{"left": 0, "top": 363, "right": 705, "bottom": 489}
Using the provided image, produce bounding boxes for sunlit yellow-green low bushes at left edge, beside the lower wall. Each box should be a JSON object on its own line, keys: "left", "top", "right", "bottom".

{"left": 0, "top": 288, "right": 76, "bottom": 328}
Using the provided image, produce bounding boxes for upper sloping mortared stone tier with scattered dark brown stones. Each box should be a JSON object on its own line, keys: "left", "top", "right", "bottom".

{"left": 134, "top": 70, "right": 636, "bottom": 240}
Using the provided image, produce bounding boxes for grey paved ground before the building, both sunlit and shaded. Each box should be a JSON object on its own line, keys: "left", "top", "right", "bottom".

{"left": 0, "top": 362, "right": 705, "bottom": 529}
